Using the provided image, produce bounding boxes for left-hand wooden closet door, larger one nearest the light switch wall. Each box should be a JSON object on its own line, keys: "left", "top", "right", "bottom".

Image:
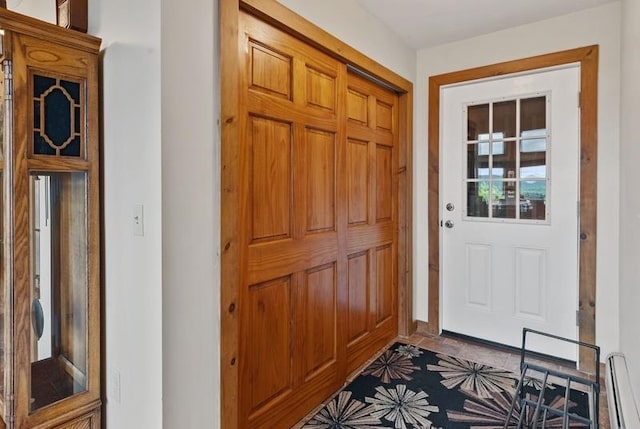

{"left": 238, "top": 13, "right": 347, "bottom": 429}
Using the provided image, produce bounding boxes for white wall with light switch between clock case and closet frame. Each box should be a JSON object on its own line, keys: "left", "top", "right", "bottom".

{"left": 89, "top": 0, "right": 220, "bottom": 422}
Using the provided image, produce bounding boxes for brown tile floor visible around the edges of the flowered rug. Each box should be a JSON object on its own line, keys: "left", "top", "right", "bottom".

{"left": 292, "top": 333, "right": 610, "bottom": 429}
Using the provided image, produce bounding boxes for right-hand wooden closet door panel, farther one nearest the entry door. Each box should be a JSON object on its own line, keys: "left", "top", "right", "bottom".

{"left": 344, "top": 73, "right": 398, "bottom": 372}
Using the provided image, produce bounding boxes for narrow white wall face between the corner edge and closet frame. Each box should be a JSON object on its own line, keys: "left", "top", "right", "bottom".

{"left": 160, "top": 0, "right": 220, "bottom": 429}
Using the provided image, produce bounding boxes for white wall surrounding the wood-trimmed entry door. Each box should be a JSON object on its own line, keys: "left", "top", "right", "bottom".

{"left": 414, "top": 2, "right": 620, "bottom": 353}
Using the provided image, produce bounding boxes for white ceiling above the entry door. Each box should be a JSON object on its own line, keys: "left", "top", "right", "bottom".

{"left": 358, "top": 0, "right": 615, "bottom": 50}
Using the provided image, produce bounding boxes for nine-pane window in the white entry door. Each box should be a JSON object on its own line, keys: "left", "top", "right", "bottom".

{"left": 464, "top": 94, "right": 549, "bottom": 223}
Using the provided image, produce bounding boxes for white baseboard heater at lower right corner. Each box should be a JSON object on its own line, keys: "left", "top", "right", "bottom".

{"left": 606, "top": 353, "right": 640, "bottom": 429}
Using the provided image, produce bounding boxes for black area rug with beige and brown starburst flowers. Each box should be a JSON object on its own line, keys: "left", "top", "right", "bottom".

{"left": 303, "top": 343, "right": 588, "bottom": 429}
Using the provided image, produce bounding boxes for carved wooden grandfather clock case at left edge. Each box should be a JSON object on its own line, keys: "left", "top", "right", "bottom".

{"left": 0, "top": 9, "right": 101, "bottom": 429}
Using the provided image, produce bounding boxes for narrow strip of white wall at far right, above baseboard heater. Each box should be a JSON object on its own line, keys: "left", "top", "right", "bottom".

{"left": 620, "top": 0, "right": 640, "bottom": 394}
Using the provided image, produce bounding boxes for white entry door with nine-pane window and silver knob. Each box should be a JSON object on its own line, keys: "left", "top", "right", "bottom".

{"left": 440, "top": 66, "right": 579, "bottom": 360}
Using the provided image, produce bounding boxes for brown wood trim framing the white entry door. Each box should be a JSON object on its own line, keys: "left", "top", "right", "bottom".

{"left": 423, "top": 45, "right": 598, "bottom": 368}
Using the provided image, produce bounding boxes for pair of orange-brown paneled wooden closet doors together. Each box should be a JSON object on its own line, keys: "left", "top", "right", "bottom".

{"left": 237, "top": 13, "right": 398, "bottom": 429}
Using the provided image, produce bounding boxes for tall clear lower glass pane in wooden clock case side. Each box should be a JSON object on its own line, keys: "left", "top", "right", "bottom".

{"left": 30, "top": 172, "right": 88, "bottom": 411}
